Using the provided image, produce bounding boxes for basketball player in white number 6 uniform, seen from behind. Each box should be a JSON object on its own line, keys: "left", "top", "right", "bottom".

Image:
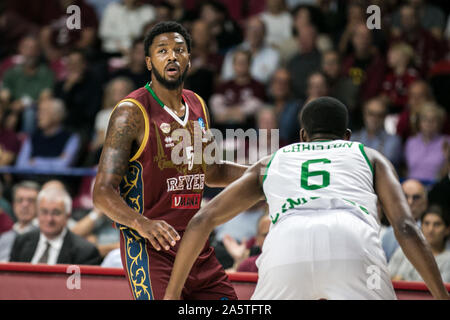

{"left": 165, "top": 97, "right": 449, "bottom": 299}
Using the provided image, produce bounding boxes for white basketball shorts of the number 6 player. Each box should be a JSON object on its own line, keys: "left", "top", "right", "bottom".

{"left": 252, "top": 210, "right": 396, "bottom": 300}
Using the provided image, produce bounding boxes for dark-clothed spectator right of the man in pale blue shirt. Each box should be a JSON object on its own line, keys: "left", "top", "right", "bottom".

{"left": 286, "top": 25, "right": 321, "bottom": 100}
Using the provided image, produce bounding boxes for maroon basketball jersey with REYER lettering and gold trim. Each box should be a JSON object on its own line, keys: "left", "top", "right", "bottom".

{"left": 120, "top": 84, "right": 209, "bottom": 231}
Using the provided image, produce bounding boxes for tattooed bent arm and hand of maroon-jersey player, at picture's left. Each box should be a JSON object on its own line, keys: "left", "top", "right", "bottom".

{"left": 93, "top": 102, "right": 179, "bottom": 250}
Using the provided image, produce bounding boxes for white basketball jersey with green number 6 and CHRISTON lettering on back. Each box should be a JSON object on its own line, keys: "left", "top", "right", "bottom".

{"left": 263, "top": 140, "right": 379, "bottom": 230}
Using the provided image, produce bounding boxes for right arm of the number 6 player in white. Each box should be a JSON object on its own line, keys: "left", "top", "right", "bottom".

{"left": 366, "top": 148, "right": 449, "bottom": 299}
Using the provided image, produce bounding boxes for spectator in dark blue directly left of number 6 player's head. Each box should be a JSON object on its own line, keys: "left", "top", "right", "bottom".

{"left": 269, "top": 68, "right": 301, "bottom": 146}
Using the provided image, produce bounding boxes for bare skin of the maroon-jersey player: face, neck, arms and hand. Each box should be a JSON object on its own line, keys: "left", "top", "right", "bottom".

{"left": 93, "top": 33, "right": 247, "bottom": 250}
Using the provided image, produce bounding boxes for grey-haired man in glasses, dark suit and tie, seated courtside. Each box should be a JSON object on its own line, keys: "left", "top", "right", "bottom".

{"left": 10, "top": 188, "right": 101, "bottom": 264}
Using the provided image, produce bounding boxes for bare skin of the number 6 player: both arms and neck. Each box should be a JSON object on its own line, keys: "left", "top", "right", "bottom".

{"left": 164, "top": 129, "right": 449, "bottom": 300}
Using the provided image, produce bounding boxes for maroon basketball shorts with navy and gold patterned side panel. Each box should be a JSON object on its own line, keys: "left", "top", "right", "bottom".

{"left": 120, "top": 228, "right": 237, "bottom": 300}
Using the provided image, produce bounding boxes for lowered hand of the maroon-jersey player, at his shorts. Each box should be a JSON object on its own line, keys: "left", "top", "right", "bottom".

{"left": 135, "top": 218, "right": 180, "bottom": 251}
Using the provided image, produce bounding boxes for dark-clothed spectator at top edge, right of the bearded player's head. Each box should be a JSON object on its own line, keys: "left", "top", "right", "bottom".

{"left": 199, "top": 0, "right": 242, "bottom": 55}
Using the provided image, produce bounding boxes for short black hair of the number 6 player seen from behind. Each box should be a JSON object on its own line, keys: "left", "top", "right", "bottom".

{"left": 300, "top": 97, "right": 348, "bottom": 137}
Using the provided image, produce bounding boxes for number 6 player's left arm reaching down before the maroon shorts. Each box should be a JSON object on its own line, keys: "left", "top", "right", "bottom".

{"left": 164, "top": 157, "right": 269, "bottom": 300}
